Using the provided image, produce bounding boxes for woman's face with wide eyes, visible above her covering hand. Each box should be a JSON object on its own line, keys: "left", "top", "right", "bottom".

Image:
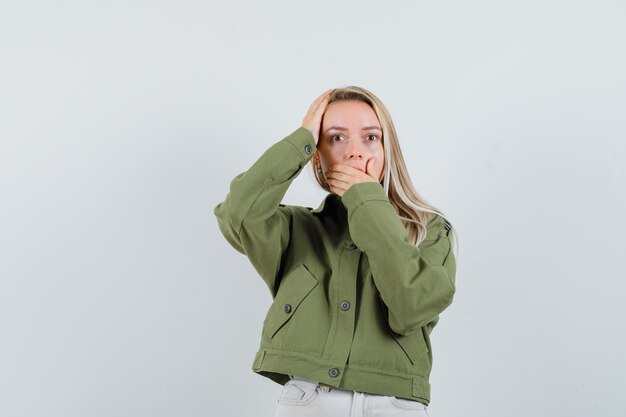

{"left": 315, "top": 100, "right": 385, "bottom": 182}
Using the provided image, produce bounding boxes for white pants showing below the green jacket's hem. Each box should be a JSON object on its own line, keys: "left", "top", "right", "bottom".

{"left": 274, "top": 376, "right": 429, "bottom": 417}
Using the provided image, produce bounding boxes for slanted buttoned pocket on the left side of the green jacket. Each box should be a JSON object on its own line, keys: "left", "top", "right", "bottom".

{"left": 263, "top": 264, "right": 318, "bottom": 339}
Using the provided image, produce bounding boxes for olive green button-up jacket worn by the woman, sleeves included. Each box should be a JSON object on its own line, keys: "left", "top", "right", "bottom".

{"left": 214, "top": 127, "right": 456, "bottom": 404}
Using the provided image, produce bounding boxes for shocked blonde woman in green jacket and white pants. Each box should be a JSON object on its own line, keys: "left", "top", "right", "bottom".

{"left": 214, "top": 86, "right": 456, "bottom": 417}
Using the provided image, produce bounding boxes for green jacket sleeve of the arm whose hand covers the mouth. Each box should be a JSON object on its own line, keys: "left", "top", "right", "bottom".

{"left": 342, "top": 182, "right": 456, "bottom": 336}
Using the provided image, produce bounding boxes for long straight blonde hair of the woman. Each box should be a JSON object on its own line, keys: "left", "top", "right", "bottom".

{"left": 311, "top": 86, "right": 458, "bottom": 257}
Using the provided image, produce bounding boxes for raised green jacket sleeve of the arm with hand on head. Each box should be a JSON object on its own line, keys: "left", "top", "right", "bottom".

{"left": 213, "top": 127, "right": 316, "bottom": 298}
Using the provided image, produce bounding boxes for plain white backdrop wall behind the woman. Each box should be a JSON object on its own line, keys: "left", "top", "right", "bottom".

{"left": 0, "top": 0, "right": 626, "bottom": 417}
